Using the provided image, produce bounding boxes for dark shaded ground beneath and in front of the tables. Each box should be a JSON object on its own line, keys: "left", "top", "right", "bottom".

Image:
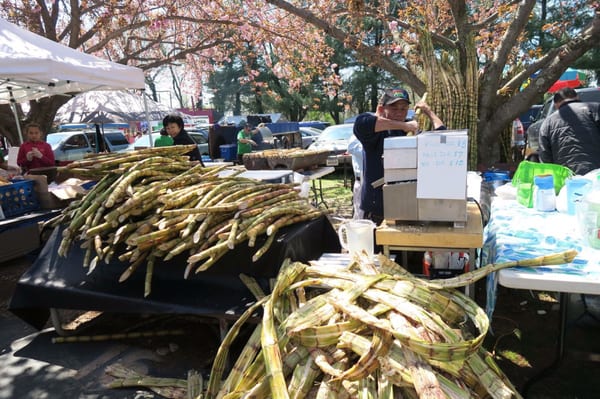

{"left": 0, "top": 253, "right": 600, "bottom": 399}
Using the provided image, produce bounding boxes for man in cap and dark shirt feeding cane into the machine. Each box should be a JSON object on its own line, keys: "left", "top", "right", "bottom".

{"left": 354, "top": 88, "right": 446, "bottom": 224}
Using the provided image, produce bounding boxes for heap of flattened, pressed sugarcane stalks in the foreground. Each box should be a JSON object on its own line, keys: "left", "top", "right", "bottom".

{"left": 202, "top": 251, "right": 576, "bottom": 399}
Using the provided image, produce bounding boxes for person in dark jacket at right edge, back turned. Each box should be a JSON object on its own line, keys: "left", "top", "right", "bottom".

{"left": 539, "top": 87, "right": 600, "bottom": 175}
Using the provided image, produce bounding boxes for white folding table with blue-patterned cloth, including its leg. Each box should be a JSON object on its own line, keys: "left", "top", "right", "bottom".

{"left": 481, "top": 198, "right": 600, "bottom": 393}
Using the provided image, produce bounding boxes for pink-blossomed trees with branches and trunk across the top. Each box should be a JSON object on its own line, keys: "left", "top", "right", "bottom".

{"left": 0, "top": 0, "right": 600, "bottom": 167}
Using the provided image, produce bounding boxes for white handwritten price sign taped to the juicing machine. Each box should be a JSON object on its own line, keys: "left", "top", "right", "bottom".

{"left": 417, "top": 130, "right": 469, "bottom": 199}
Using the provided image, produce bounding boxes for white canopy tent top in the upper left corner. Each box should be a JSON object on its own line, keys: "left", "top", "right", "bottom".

{"left": 0, "top": 18, "right": 145, "bottom": 144}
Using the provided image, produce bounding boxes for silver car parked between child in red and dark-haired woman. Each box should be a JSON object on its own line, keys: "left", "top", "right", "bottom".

{"left": 46, "top": 130, "right": 133, "bottom": 165}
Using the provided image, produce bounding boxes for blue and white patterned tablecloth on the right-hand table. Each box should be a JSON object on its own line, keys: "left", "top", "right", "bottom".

{"left": 481, "top": 198, "right": 600, "bottom": 318}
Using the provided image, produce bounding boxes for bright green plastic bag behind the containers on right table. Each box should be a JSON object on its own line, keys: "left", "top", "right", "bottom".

{"left": 512, "top": 161, "right": 574, "bottom": 208}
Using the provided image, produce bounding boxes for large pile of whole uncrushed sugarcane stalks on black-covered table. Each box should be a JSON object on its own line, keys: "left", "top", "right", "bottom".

{"left": 53, "top": 146, "right": 322, "bottom": 296}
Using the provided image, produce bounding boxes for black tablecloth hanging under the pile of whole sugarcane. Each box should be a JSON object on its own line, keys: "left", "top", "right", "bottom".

{"left": 9, "top": 216, "right": 340, "bottom": 329}
